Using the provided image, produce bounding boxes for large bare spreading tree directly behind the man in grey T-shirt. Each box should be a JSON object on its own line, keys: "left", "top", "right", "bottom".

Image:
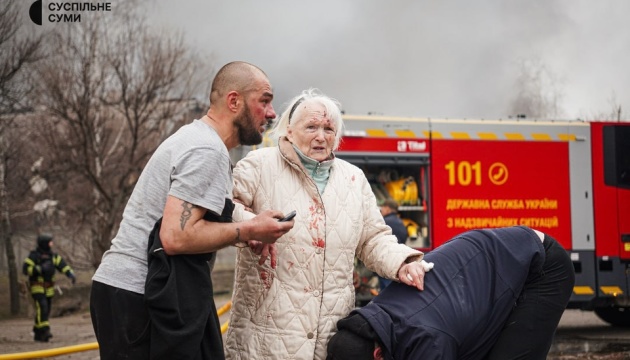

{"left": 32, "top": 4, "right": 207, "bottom": 266}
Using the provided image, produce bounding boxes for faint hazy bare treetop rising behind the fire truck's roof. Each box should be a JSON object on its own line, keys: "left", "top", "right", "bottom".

{"left": 509, "top": 59, "right": 564, "bottom": 119}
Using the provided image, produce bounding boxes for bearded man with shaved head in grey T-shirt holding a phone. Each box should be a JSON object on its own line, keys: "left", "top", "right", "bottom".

{"left": 90, "top": 61, "right": 294, "bottom": 360}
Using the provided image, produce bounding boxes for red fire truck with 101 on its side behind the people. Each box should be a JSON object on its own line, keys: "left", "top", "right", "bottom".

{"left": 336, "top": 115, "right": 630, "bottom": 326}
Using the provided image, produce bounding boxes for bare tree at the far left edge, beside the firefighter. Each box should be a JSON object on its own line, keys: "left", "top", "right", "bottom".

{"left": 0, "top": 1, "right": 42, "bottom": 315}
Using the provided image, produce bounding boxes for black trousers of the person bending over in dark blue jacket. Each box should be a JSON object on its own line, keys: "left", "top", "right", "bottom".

{"left": 487, "top": 235, "right": 575, "bottom": 360}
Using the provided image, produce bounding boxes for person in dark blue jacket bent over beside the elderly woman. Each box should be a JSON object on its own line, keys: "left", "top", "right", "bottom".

{"left": 327, "top": 226, "right": 575, "bottom": 360}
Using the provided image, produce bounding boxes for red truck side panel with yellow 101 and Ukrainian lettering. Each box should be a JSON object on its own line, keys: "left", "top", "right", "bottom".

{"left": 430, "top": 140, "right": 571, "bottom": 249}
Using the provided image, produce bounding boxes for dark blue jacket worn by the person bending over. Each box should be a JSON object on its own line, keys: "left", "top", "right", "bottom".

{"left": 355, "top": 226, "right": 545, "bottom": 359}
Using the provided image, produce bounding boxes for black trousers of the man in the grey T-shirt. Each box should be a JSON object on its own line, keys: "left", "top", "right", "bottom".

{"left": 90, "top": 281, "right": 151, "bottom": 360}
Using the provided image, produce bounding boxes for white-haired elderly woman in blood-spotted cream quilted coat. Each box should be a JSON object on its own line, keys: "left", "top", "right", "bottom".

{"left": 225, "top": 89, "right": 426, "bottom": 359}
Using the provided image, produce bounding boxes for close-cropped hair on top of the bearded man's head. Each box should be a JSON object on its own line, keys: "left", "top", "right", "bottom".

{"left": 210, "top": 61, "right": 267, "bottom": 105}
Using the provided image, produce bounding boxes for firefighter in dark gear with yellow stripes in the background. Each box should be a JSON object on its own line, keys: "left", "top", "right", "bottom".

{"left": 22, "top": 234, "right": 77, "bottom": 342}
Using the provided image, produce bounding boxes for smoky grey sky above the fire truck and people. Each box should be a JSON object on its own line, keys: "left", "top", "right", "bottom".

{"left": 148, "top": 0, "right": 630, "bottom": 119}
